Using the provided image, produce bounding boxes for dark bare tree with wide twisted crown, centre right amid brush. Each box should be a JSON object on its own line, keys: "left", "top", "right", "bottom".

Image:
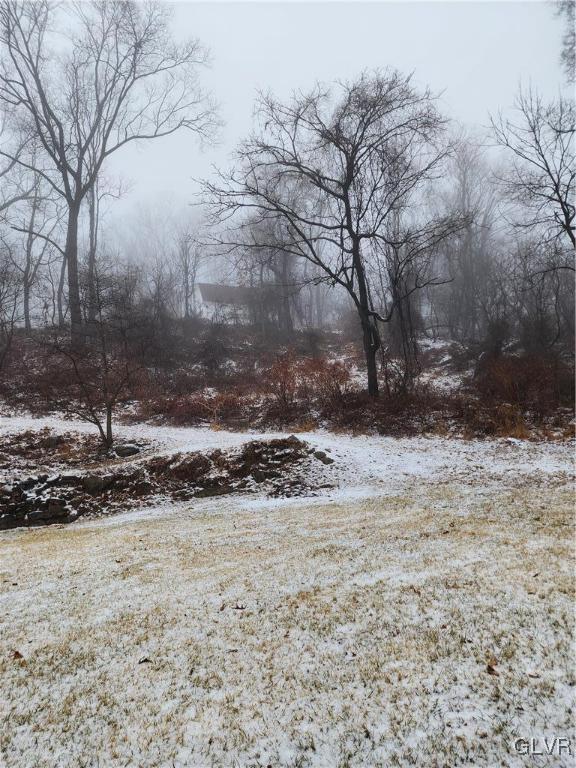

{"left": 205, "top": 71, "right": 462, "bottom": 396}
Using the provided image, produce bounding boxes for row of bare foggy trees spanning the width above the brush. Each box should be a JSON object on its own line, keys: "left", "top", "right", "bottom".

{"left": 0, "top": 0, "right": 576, "bottom": 397}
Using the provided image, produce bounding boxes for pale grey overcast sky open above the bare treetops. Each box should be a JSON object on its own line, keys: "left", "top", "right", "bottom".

{"left": 109, "top": 0, "right": 563, "bottom": 222}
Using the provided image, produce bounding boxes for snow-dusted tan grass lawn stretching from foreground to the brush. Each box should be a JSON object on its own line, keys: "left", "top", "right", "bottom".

{"left": 0, "top": 418, "right": 575, "bottom": 768}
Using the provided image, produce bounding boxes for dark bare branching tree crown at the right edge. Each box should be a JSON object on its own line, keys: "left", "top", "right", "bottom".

{"left": 492, "top": 90, "right": 576, "bottom": 252}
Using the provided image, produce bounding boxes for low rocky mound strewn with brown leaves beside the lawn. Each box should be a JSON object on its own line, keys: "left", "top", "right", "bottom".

{"left": 0, "top": 436, "right": 326, "bottom": 529}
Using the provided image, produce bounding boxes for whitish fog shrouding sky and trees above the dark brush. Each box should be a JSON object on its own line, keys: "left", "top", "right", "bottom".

{"left": 0, "top": 0, "right": 576, "bottom": 384}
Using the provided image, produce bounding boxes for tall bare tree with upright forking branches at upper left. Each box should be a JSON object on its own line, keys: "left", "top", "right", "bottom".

{"left": 0, "top": 0, "right": 214, "bottom": 338}
